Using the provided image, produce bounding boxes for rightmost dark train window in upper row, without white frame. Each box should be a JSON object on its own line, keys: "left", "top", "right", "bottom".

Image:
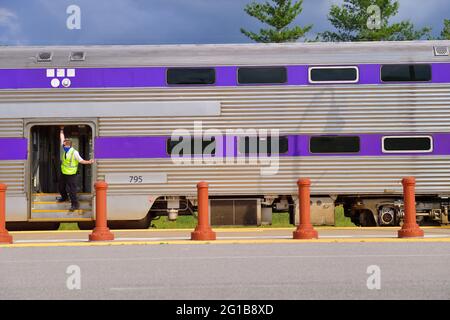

{"left": 381, "top": 64, "right": 431, "bottom": 82}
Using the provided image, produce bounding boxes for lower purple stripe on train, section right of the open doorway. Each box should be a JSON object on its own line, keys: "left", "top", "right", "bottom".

{"left": 95, "top": 133, "right": 450, "bottom": 159}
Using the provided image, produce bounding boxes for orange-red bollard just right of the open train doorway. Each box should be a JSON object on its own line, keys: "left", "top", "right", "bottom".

{"left": 89, "top": 181, "right": 114, "bottom": 241}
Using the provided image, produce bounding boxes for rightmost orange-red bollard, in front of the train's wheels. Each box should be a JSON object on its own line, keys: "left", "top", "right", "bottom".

{"left": 398, "top": 177, "right": 424, "bottom": 238}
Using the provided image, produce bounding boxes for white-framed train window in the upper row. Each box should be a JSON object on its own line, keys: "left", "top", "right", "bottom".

{"left": 308, "top": 67, "right": 359, "bottom": 83}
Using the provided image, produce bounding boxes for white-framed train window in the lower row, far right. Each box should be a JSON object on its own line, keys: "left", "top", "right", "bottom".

{"left": 382, "top": 136, "right": 433, "bottom": 153}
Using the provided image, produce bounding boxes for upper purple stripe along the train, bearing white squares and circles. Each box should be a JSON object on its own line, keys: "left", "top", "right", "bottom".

{"left": 0, "top": 63, "right": 450, "bottom": 89}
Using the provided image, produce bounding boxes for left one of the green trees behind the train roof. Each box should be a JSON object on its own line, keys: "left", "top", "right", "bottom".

{"left": 241, "top": 0, "right": 312, "bottom": 43}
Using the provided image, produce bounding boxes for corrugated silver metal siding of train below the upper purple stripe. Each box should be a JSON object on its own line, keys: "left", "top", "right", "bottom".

{"left": 0, "top": 84, "right": 450, "bottom": 195}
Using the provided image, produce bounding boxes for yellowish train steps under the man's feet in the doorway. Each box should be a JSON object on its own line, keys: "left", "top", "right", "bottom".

{"left": 31, "top": 193, "right": 92, "bottom": 221}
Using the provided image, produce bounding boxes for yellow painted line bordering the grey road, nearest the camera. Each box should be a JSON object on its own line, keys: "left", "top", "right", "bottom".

{"left": 0, "top": 238, "right": 450, "bottom": 248}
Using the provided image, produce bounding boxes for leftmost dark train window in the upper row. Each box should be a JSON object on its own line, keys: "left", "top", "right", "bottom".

{"left": 167, "top": 68, "right": 216, "bottom": 85}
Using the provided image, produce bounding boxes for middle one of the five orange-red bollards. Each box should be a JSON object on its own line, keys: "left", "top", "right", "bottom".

{"left": 191, "top": 181, "right": 216, "bottom": 240}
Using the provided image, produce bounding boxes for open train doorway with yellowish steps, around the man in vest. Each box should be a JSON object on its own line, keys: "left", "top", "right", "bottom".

{"left": 29, "top": 123, "right": 94, "bottom": 221}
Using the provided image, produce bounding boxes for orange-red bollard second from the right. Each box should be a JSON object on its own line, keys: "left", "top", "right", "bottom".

{"left": 294, "top": 178, "right": 319, "bottom": 239}
